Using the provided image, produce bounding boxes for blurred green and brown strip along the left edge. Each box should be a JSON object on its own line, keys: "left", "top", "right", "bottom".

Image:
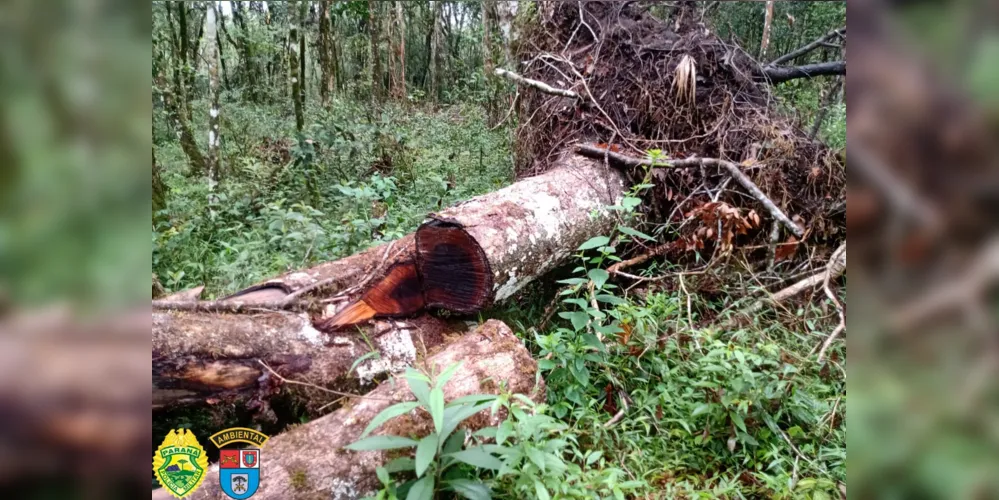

{"left": 0, "top": 0, "right": 152, "bottom": 498}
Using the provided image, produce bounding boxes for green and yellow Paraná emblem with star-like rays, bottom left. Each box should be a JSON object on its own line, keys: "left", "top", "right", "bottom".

{"left": 153, "top": 429, "right": 208, "bottom": 498}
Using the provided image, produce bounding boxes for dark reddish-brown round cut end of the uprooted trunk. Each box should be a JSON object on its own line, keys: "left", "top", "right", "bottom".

{"left": 416, "top": 218, "right": 493, "bottom": 313}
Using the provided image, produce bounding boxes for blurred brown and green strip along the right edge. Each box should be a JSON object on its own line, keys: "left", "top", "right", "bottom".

{"left": 847, "top": 1, "right": 999, "bottom": 498}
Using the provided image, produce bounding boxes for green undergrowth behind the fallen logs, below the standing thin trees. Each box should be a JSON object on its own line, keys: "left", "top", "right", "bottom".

{"left": 152, "top": 100, "right": 513, "bottom": 297}
